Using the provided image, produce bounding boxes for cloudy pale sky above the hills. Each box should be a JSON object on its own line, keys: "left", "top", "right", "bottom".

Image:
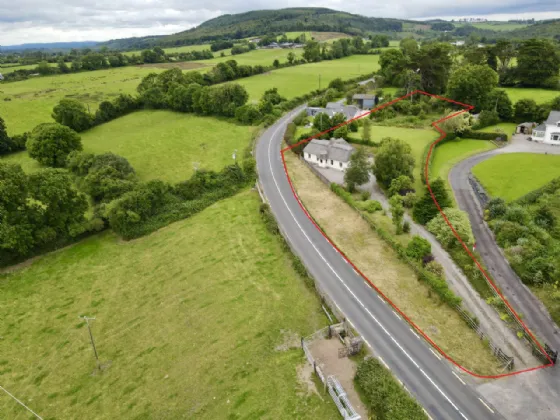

{"left": 0, "top": 0, "right": 560, "bottom": 45}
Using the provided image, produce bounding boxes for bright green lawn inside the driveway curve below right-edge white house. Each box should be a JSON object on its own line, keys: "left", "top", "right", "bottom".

{"left": 472, "top": 153, "right": 560, "bottom": 201}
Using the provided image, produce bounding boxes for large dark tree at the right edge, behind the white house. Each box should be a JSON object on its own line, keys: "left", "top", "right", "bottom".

{"left": 517, "top": 39, "right": 560, "bottom": 87}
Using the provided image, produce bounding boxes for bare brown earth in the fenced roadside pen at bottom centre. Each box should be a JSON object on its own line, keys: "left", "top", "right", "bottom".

{"left": 309, "top": 336, "right": 368, "bottom": 419}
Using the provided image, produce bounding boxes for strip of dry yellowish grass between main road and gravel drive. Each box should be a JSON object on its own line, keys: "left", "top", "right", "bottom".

{"left": 285, "top": 152, "right": 501, "bottom": 375}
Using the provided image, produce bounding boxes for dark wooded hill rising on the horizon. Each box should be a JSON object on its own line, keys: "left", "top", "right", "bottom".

{"left": 101, "top": 7, "right": 419, "bottom": 49}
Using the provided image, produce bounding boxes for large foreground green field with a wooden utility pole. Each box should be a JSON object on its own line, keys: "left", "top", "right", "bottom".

{"left": 0, "top": 191, "right": 338, "bottom": 419}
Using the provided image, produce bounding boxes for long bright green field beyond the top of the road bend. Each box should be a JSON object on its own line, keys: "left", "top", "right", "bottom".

{"left": 238, "top": 55, "right": 379, "bottom": 100}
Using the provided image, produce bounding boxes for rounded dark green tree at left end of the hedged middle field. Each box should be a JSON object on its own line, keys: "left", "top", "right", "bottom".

{"left": 27, "top": 123, "right": 82, "bottom": 168}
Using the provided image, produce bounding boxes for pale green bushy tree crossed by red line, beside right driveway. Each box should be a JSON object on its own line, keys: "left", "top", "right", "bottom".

{"left": 426, "top": 208, "right": 474, "bottom": 248}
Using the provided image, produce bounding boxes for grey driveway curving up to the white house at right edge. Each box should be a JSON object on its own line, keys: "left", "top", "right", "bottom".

{"left": 449, "top": 136, "right": 560, "bottom": 350}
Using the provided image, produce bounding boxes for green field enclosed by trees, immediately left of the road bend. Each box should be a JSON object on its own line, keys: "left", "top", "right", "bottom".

{"left": 0, "top": 110, "right": 255, "bottom": 182}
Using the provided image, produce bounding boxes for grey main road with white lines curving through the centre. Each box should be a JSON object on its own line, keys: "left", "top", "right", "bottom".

{"left": 256, "top": 108, "right": 504, "bottom": 420}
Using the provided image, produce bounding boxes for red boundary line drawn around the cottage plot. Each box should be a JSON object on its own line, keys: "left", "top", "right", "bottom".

{"left": 280, "top": 90, "right": 554, "bottom": 379}
